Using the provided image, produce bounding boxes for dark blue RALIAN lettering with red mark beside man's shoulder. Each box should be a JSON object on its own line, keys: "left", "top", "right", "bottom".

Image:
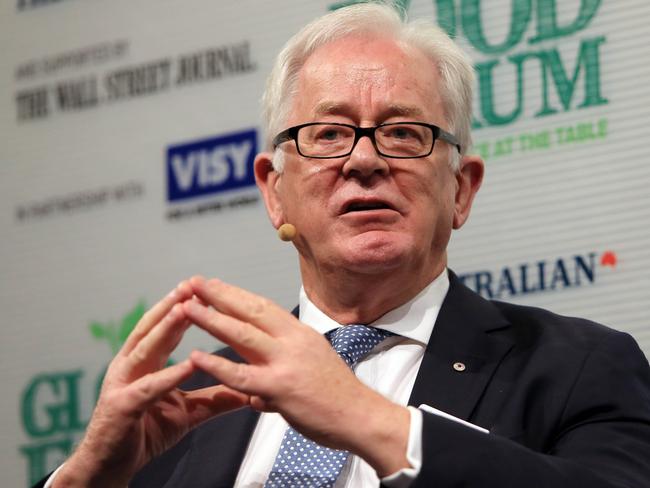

{"left": 459, "top": 251, "right": 618, "bottom": 300}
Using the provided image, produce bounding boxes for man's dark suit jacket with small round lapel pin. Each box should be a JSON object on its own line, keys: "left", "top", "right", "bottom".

{"left": 36, "top": 274, "right": 650, "bottom": 488}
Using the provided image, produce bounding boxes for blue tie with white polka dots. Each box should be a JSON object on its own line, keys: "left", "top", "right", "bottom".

{"left": 264, "top": 325, "right": 393, "bottom": 488}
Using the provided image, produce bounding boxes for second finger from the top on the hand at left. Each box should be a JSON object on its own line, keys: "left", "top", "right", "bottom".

{"left": 123, "top": 304, "right": 189, "bottom": 377}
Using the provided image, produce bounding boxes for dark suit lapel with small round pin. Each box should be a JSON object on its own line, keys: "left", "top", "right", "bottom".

{"left": 409, "top": 272, "right": 513, "bottom": 420}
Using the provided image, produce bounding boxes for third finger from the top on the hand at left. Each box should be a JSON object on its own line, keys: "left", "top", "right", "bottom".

{"left": 120, "top": 359, "right": 194, "bottom": 412}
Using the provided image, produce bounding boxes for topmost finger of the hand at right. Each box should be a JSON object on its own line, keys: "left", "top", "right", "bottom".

{"left": 189, "top": 277, "right": 288, "bottom": 336}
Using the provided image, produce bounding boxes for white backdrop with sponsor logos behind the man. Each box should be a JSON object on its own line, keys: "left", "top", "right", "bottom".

{"left": 0, "top": 0, "right": 650, "bottom": 486}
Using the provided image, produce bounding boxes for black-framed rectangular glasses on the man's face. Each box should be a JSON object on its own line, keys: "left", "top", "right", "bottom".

{"left": 273, "top": 122, "right": 460, "bottom": 159}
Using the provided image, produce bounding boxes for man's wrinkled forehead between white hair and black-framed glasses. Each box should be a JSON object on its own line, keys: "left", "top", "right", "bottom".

{"left": 293, "top": 37, "right": 440, "bottom": 123}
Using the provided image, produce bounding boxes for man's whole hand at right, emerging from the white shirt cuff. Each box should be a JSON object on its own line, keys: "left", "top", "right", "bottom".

{"left": 183, "top": 277, "right": 410, "bottom": 477}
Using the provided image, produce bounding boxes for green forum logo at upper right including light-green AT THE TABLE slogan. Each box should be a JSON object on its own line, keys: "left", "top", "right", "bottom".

{"left": 330, "top": 0, "right": 609, "bottom": 159}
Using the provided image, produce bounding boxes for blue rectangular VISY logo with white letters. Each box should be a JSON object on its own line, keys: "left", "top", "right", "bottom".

{"left": 167, "top": 129, "right": 257, "bottom": 202}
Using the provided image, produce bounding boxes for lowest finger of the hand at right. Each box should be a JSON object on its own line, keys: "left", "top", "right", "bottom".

{"left": 190, "top": 351, "right": 273, "bottom": 396}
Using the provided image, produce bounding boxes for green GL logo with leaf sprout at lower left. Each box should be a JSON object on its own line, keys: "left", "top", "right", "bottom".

{"left": 19, "top": 301, "right": 146, "bottom": 486}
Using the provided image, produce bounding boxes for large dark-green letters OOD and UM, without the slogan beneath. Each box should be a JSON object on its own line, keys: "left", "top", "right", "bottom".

{"left": 454, "top": 0, "right": 607, "bottom": 127}
